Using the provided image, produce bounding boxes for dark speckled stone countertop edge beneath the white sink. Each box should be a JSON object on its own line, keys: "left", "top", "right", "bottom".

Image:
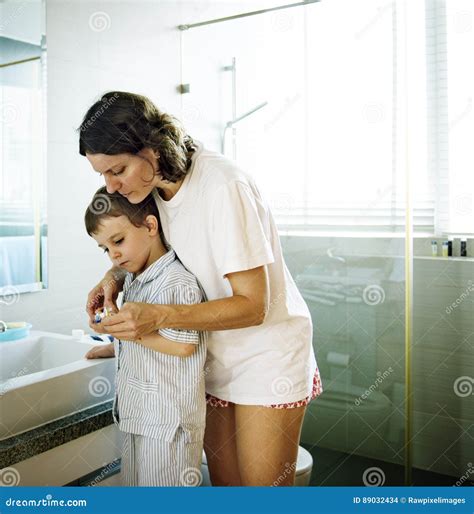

{"left": 0, "top": 400, "right": 114, "bottom": 469}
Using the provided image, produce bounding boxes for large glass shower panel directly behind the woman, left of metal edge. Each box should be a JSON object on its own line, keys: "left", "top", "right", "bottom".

{"left": 182, "top": 0, "right": 406, "bottom": 485}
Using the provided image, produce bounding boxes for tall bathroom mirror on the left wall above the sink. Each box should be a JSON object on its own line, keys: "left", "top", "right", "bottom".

{"left": 0, "top": 0, "right": 47, "bottom": 294}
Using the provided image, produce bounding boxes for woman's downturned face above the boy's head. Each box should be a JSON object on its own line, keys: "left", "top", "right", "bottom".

{"left": 86, "top": 148, "right": 162, "bottom": 203}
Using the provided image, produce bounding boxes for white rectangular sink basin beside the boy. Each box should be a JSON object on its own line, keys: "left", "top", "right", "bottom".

{"left": 0, "top": 331, "right": 115, "bottom": 440}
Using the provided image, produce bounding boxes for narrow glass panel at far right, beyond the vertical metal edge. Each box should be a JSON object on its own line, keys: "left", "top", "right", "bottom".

{"left": 412, "top": 0, "right": 474, "bottom": 485}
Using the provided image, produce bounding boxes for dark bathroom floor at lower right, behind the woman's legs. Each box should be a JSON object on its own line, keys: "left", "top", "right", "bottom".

{"left": 301, "top": 443, "right": 474, "bottom": 486}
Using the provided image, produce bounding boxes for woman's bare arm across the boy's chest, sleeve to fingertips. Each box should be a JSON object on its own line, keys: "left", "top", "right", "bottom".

{"left": 96, "top": 266, "right": 269, "bottom": 340}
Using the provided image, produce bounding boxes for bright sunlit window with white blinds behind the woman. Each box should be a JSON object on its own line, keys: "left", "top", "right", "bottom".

{"left": 183, "top": 0, "right": 474, "bottom": 235}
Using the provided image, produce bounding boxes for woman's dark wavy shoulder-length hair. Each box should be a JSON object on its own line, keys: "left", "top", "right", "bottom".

{"left": 77, "top": 91, "right": 195, "bottom": 182}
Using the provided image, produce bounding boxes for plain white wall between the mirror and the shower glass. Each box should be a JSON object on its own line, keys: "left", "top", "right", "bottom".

{"left": 1, "top": 0, "right": 278, "bottom": 334}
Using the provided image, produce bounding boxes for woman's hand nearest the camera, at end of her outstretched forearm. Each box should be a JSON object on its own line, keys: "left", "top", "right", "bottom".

{"left": 98, "top": 302, "right": 166, "bottom": 341}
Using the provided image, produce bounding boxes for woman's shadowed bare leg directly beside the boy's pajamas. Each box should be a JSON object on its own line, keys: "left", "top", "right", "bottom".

{"left": 204, "top": 403, "right": 241, "bottom": 486}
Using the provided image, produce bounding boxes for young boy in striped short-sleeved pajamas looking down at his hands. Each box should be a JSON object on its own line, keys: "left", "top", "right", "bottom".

{"left": 85, "top": 187, "right": 206, "bottom": 486}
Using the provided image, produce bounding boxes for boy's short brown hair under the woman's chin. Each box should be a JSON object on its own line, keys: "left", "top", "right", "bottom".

{"left": 84, "top": 187, "right": 161, "bottom": 236}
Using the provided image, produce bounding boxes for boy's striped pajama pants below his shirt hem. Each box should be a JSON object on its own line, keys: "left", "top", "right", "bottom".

{"left": 121, "top": 429, "right": 203, "bottom": 487}
